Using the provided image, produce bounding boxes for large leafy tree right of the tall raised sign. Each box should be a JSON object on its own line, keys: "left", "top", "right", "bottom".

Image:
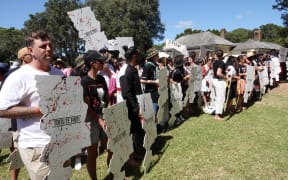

{"left": 87, "top": 0, "right": 165, "bottom": 50}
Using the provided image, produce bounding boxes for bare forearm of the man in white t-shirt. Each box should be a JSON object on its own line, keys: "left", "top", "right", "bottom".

{"left": 0, "top": 106, "right": 43, "bottom": 118}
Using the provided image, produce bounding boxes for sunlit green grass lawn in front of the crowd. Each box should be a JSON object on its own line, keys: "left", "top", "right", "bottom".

{"left": 0, "top": 83, "right": 288, "bottom": 180}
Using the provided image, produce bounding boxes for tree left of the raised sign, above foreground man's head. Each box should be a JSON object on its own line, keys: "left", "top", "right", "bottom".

{"left": 24, "top": 0, "right": 83, "bottom": 65}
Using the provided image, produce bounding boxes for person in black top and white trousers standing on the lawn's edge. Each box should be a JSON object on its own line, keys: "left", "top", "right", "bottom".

{"left": 212, "top": 50, "right": 227, "bottom": 121}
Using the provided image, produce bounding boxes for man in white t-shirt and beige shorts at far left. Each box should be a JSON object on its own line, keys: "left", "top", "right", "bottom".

{"left": 0, "top": 31, "right": 63, "bottom": 180}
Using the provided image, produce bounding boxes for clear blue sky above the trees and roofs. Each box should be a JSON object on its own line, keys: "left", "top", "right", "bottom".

{"left": 0, "top": 0, "right": 283, "bottom": 41}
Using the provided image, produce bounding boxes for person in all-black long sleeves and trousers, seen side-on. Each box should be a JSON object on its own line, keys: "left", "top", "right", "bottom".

{"left": 120, "top": 47, "right": 145, "bottom": 162}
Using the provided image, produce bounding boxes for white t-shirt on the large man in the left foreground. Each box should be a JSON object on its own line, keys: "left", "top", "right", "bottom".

{"left": 0, "top": 64, "right": 63, "bottom": 148}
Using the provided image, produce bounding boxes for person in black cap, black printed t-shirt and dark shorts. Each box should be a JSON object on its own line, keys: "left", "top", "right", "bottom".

{"left": 81, "top": 50, "right": 112, "bottom": 180}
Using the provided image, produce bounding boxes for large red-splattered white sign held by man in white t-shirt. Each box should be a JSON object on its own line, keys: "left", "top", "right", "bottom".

{"left": 36, "top": 76, "right": 91, "bottom": 179}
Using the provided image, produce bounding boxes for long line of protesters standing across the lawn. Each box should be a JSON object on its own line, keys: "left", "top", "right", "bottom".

{"left": 0, "top": 31, "right": 279, "bottom": 179}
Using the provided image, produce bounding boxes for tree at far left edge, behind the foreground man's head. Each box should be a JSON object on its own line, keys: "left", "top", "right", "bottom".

{"left": 0, "top": 28, "right": 25, "bottom": 62}
